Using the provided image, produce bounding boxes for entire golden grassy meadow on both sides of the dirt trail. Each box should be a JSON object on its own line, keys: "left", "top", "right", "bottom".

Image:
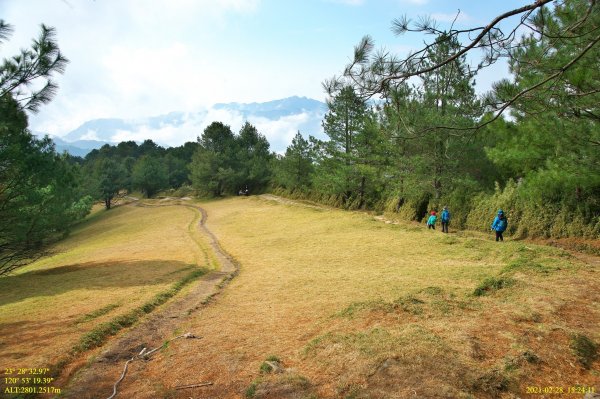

{"left": 0, "top": 196, "right": 600, "bottom": 399}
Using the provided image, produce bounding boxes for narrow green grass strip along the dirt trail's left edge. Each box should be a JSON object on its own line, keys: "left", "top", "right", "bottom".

{"left": 71, "top": 270, "right": 205, "bottom": 354}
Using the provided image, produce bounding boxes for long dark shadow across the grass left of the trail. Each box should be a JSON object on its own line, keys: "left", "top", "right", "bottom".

{"left": 0, "top": 260, "right": 196, "bottom": 306}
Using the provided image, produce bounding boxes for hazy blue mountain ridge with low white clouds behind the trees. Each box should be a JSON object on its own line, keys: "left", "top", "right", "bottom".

{"left": 48, "top": 96, "right": 327, "bottom": 156}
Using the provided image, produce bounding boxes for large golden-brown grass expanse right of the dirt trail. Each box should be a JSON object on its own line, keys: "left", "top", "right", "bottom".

{"left": 115, "top": 197, "right": 600, "bottom": 398}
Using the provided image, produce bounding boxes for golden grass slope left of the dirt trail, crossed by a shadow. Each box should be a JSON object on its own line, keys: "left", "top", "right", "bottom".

{"left": 0, "top": 206, "right": 207, "bottom": 367}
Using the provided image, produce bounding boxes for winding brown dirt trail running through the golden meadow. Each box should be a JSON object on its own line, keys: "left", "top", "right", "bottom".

{"left": 61, "top": 205, "right": 238, "bottom": 399}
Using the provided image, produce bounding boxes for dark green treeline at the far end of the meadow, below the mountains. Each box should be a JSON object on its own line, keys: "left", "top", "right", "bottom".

{"left": 80, "top": 122, "right": 274, "bottom": 209}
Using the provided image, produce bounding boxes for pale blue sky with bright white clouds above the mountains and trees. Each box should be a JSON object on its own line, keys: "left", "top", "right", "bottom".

{"left": 0, "top": 0, "right": 533, "bottom": 144}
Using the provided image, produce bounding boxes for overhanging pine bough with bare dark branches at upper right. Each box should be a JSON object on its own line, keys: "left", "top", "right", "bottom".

{"left": 323, "top": 0, "right": 600, "bottom": 130}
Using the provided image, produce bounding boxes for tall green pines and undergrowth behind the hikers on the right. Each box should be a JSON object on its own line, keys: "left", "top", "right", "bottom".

{"left": 274, "top": 0, "right": 600, "bottom": 238}
